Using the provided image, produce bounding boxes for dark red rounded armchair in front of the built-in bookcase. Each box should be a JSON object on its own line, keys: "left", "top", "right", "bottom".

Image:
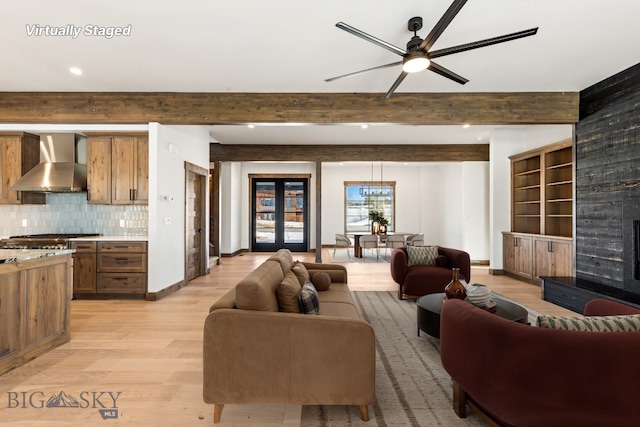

{"left": 391, "top": 246, "right": 471, "bottom": 299}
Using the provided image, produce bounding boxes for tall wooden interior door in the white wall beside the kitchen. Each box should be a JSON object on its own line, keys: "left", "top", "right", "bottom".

{"left": 185, "top": 164, "right": 208, "bottom": 281}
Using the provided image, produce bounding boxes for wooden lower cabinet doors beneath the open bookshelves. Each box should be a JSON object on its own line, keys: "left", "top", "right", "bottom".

{"left": 503, "top": 232, "right": 573, "bottom": 284}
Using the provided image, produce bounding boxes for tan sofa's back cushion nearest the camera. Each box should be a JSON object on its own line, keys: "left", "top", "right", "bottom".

{"left": 236, "top": 260, "right": 284, "bottom": 311}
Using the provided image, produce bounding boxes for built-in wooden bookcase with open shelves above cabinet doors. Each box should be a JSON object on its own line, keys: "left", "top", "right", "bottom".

{"left": 503, "top": 140, "right": 573, "bottom": 284}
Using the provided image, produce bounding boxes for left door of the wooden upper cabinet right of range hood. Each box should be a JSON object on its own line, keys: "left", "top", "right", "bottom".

{"left": 87, "top": 136, "right": 112, "bottom": 205}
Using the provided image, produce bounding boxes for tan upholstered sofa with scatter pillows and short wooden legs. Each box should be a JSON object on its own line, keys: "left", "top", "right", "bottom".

{"left": 203, "top": 250, "right": 376, "bottom": 422}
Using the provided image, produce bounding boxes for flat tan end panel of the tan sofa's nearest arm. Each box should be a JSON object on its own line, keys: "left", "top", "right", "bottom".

{"left": 203, "top": 309, "right": 375, "bottom": 405}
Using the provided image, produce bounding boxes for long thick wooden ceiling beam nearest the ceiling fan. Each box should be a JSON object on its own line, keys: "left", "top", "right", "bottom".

{"left": 0, "top": 92, "right": 579, "bottom": 125}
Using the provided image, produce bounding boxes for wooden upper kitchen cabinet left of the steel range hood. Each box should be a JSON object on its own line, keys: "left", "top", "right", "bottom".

{"left": 0, "top": 132, "right": 46, "bottom": 204}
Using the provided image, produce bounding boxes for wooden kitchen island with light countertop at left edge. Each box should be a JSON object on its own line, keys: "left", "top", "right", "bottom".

{"left": 0, "top": 249, "right": 73, "bottom": 375}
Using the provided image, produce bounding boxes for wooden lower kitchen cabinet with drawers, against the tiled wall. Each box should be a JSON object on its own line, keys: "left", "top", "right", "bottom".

{"left": 73, "top": 241, "right": 147, "bottom": 296}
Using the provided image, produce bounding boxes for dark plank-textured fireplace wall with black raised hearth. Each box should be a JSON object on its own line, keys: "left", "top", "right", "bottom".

{"left": 543, "top": 64, "right": 640, "bottom": 313}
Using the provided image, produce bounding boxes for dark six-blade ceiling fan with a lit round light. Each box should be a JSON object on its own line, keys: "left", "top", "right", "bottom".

{"left": 325, "top": 0, "right": 538, "bottom": 99}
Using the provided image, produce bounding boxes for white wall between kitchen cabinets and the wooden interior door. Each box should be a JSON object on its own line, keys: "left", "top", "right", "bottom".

{"left": 148, "top": 123, "right": 209, "bottom": 292}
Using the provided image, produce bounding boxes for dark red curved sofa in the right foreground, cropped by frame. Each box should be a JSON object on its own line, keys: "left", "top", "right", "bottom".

{"left": 440, "top": 300, "right": 640, "bottom": 427}
